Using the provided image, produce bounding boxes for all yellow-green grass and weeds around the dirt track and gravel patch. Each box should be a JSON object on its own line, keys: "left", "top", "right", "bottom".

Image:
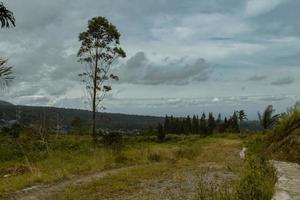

{"left": 0, "top": 132, "right": 274, "bottom": 200}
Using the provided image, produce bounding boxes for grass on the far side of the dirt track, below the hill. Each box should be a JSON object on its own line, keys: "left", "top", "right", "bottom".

{"left": 0, "top": 136, "right": 240, "bottom": 196}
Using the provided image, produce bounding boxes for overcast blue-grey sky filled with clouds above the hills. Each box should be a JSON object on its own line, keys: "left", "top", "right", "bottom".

{"left": 0, "top": 0, "right": 300, "bottom": 118}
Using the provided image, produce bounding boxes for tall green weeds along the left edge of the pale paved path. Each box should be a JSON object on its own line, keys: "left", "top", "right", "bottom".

{"left": 194, "top": 157, "right": 277, "bottom": 200}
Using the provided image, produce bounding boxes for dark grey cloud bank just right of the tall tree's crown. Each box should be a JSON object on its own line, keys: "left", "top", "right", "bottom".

{"left": 116, "top": 52, "right": 212, "bottom": 85}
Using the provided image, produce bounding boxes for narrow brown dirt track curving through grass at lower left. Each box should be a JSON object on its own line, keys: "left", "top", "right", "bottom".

{"left": 7, "top": 167, "right": 134, "bottom": 200}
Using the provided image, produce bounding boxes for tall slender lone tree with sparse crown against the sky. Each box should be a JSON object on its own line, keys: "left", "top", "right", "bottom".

{"left": 77, "top": 17, "right": 126, "bottom": 141}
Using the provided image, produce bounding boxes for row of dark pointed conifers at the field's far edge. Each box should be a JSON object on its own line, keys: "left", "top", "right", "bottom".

{"left": 149, "top": 110, "right": 247, "bottom": 136}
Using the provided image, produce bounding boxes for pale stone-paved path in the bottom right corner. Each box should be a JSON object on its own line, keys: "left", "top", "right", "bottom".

{"left": 273, "top": 161, "right": 300, "bottom": 200}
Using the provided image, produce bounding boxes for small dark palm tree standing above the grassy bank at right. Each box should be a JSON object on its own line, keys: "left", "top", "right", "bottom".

{"left": 258, "top": 105, "right": 280, "bottom": 132}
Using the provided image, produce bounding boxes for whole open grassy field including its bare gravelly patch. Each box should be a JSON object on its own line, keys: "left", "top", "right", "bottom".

{"left": 0, "top": 135, "right": 276, "bottom": 199}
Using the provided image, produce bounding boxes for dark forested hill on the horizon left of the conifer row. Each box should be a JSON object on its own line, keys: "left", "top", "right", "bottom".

{"left": 0, "top": 101, "right": 164, "bottom": 130}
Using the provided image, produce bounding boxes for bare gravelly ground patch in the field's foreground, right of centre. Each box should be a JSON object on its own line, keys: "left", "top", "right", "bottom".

{"left": 110, "top": 162, "right": 237, "bottom": 200}
